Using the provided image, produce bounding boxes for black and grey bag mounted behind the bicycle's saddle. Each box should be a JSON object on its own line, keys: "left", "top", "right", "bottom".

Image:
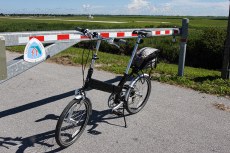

{"left": 132, "top": 47, "right": 160, "bottom": 70}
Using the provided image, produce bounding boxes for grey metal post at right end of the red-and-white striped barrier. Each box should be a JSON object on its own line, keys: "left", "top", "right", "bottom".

{"left": 178, "top": 18, "right": 189, "bottom": 76}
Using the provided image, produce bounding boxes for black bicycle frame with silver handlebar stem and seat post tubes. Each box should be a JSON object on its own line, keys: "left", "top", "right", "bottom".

{"left": 75, "top": 36, "right": 142, "bottom": 99}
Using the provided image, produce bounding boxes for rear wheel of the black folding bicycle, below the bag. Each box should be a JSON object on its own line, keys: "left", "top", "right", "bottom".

{"left": 126, "top": 74, "right": 151, "bottom": 114}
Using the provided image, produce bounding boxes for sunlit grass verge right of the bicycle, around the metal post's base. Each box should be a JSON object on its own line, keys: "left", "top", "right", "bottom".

{"left": 153, "top": 63, "right": 230, "bottom": 96}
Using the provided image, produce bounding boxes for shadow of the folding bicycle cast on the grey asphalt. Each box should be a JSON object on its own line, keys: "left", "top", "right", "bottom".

{"left": 0, "top": 109, "right": 129, "bottom": 153}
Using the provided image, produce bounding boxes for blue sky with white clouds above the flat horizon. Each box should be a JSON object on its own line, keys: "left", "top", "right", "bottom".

{"left": 0, "top": 0, "right": 229, "bottom": 16}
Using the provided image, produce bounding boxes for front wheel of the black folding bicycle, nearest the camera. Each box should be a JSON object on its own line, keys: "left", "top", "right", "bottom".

{"left": 55, "top": 98, "right": 92, "bottom": 147}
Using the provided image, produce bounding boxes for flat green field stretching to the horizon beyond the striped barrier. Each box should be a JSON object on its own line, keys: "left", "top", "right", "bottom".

{"left": 0, "top": 16, "right": 227, "bottom": 32}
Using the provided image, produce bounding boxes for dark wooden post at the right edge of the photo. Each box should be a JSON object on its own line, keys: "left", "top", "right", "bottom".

{"left": 221, "top": 0, "right": 230, "bottom": 79}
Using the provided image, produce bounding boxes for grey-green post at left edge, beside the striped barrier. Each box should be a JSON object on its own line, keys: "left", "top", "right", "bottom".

{"left": 0, "top": 36, "right": 7, "bottom": 80}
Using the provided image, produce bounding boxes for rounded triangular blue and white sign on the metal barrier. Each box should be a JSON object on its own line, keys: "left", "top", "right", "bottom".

{"left": 24, "top": 38, "right": 46, "bottom": 63}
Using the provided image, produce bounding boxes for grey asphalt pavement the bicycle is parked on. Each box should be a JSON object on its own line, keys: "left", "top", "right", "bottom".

{"left": 0, "top": 54, "right": 230, "bottom": 153}
